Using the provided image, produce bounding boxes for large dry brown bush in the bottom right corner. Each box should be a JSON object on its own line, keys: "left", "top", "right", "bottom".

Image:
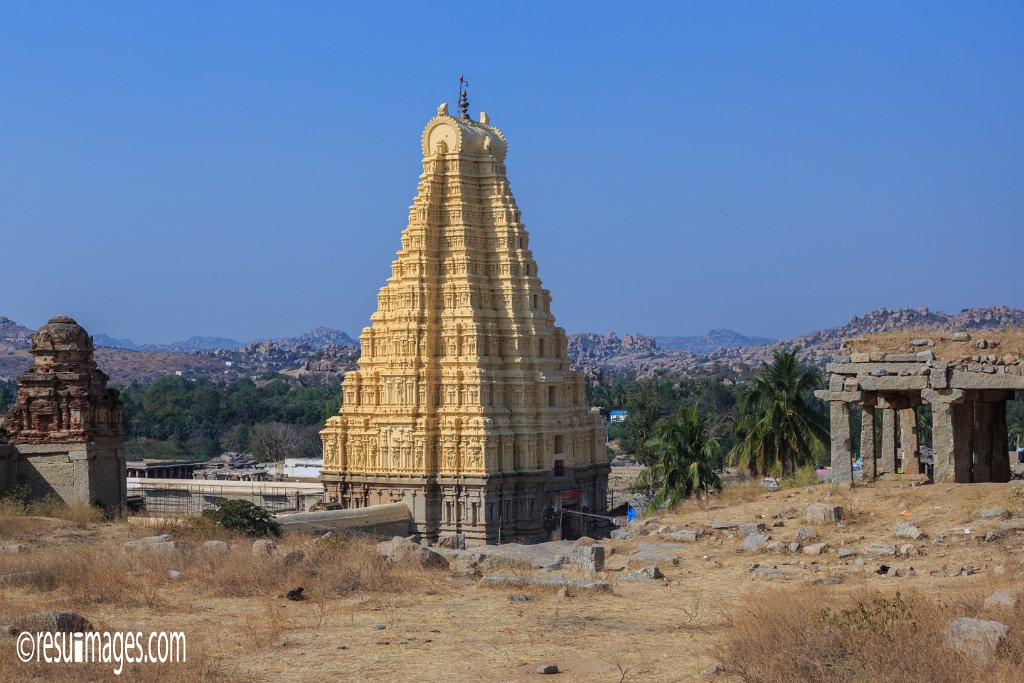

{"left": 719, "top": 586, "right": 1024, "bottom": 683}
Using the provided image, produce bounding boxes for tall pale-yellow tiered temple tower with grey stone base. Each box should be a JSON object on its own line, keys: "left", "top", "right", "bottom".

{"left": 322, "top": 94, "right": 608, "bottom": 544}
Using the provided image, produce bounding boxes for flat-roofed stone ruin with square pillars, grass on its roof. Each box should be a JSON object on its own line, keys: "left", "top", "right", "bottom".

{"left": 815, "top": 332, "right": 1024, "bottom": 483}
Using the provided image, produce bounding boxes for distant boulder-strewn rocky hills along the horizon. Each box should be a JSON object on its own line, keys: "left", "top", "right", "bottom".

{"left": 0, "top": 306, "right": 1024, "bottom": 384}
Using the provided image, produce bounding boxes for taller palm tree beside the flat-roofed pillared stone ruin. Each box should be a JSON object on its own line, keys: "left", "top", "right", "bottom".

{"left": 729, "top": 349, "right": 828, "bottom": 475}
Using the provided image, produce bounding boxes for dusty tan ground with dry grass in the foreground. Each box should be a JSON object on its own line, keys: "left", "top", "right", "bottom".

{"left": 0, "top": 482, "right": 1024, "bottom": 681}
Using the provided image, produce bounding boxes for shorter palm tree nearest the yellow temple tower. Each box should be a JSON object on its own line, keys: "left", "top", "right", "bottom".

{"left": 637, "top": 403, "right": 722, "bottom": 510}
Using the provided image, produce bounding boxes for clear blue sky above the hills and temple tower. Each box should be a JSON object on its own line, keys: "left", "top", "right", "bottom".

{"left": 0, "top": 1, "right": 1024, "bottom": 342}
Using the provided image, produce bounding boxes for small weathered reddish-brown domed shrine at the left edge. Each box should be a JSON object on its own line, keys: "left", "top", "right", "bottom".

{"left": 0, "top": 315, "right": 127, "bottom": 508}
